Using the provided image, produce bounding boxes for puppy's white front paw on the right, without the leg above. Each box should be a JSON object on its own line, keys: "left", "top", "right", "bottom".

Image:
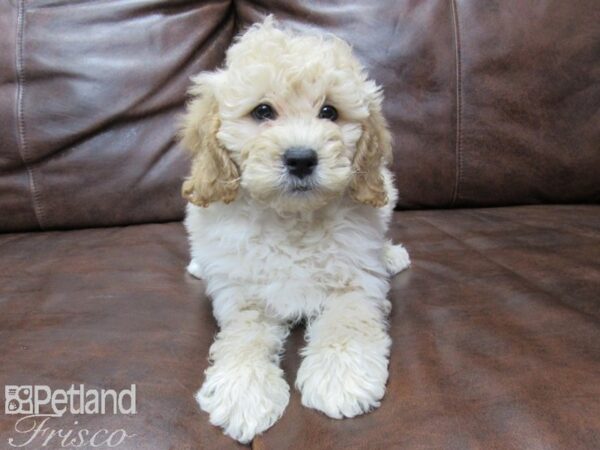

{"left": 296, "top": 349, "right": 388, "bottom": 419}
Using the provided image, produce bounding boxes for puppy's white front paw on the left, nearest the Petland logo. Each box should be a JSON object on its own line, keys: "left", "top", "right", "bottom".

{"left": 196, "top": 362, "right": 290, "bottom": 444}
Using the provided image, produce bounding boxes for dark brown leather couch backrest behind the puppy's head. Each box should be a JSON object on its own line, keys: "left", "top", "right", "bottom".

{"left": 0, "top": 0, "right": 600, "bottom": 230}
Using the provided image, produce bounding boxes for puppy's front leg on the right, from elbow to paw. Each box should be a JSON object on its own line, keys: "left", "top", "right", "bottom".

{"left": 296, "top": 292, "right": 391, "bottom": 419}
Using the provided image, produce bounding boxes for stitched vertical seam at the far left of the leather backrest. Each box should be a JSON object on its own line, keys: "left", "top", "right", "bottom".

{"left": 15, "top": 0, "right": 44, "bottom": 229}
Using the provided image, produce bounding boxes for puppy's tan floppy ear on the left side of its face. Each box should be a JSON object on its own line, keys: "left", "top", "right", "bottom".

{"left": 180, "top": 73, "right": 239, "bottom": 207}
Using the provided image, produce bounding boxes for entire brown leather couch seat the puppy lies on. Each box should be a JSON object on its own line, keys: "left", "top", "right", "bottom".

{"left": 0, "top": 206, "right": 600, "bottom": 450}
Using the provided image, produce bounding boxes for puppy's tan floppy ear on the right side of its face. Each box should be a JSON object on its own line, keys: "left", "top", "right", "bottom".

{"left": 350, "top": 93, "right": 392, "bottom": 208}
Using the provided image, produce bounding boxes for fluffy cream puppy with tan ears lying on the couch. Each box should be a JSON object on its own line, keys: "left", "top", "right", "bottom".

{"left": 181, "top": 17, "right": 409, "bottom": 443}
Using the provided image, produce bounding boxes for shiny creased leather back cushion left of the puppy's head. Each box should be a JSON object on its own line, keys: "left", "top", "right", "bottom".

{"left": 0, "top": 0, "right": 234, "bottom": 230}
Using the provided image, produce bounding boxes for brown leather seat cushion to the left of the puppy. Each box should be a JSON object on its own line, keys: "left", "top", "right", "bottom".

{"left": 0, "top": 223, "right": 244, "bottom": 450}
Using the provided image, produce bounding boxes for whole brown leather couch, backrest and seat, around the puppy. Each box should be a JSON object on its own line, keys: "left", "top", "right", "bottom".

{"left": 0, "top": 0, "right": 600, "bottom": 450}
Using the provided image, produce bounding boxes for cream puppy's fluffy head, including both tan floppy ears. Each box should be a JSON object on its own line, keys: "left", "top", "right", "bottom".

{"left": 183, "top": 20, "right": 391, "bottom": 211}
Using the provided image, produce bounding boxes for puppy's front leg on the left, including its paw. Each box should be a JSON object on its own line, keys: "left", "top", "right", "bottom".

{"left": 196, "top": 307, "right": 290, "bottom": 443}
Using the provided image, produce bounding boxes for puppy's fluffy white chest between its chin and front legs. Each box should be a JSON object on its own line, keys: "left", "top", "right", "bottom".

{"left": 186, "top": 200, "right": 385, "bottom": 320}
